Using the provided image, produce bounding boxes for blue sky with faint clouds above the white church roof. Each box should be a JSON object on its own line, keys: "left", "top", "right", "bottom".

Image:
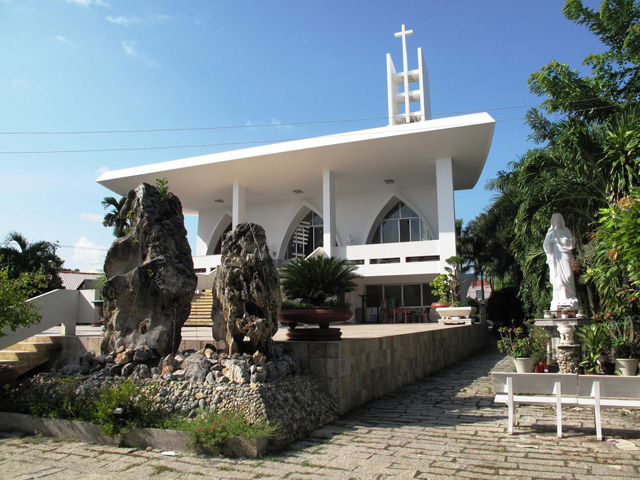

{"left": 0, "top": 0, "right": 602, "bottom": 270}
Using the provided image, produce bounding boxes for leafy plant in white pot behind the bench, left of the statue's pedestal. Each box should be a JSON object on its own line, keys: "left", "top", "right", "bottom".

{"left": 498, "top": 322, "right": 549, "bottom": 373}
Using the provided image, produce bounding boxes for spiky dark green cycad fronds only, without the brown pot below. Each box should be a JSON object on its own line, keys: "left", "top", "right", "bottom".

{"left": 280, "top": 257, "right": 360, "bottom": 307}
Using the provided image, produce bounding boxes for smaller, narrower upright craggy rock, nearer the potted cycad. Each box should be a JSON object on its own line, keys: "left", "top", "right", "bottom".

{"left": 211, "top": 223, "right": 282, "bottom": 356}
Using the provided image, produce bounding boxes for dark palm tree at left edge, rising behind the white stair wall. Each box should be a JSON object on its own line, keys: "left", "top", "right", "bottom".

{"left": 0, "top": 232, "right": 64, "bottom": 295}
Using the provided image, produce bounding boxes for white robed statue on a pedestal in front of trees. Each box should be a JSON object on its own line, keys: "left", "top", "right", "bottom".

{"left": 544, "top": 213, "right": 578, "bottom": 310}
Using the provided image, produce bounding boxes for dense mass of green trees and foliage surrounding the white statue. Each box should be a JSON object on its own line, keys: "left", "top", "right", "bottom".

{"left": 476, "top": 0, "right": 640, "bottom": 316}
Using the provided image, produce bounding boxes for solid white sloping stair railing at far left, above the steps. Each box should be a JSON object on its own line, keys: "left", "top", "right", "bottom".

{"left": 0, "top": 290, "right": 98, "bottom": 350}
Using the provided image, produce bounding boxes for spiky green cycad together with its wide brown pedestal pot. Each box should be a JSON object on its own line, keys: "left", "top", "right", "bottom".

{"left": 278, "top": 257, "right": 360, "bottom": 340}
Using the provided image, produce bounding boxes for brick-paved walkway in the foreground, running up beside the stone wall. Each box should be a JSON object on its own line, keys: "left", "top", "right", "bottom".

{"left": 0, "top": 344, "right": 640, "bottom": 480}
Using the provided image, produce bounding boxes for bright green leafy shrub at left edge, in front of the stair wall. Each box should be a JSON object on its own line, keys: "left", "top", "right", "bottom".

{"left": 0, "top": 257, "right": 47, "bottom": 337}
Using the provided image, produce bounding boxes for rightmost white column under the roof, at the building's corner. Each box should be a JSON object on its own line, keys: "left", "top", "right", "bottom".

{"left": 436, "top": 158, "right": 456, "bottom": 272}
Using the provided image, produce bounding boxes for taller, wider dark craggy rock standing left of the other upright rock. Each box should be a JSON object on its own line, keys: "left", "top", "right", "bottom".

{"left": 101, "top": 183, "right": 197, "bottom": 356}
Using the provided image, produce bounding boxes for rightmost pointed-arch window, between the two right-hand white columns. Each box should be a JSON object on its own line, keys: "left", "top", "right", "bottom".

{"left": 371, "top": 201, "right": 429, "bottom": 243}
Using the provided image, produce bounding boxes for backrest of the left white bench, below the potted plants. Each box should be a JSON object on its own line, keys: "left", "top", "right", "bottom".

{"left": 492, "top": 372, "right": 576, "bottom": 396}
